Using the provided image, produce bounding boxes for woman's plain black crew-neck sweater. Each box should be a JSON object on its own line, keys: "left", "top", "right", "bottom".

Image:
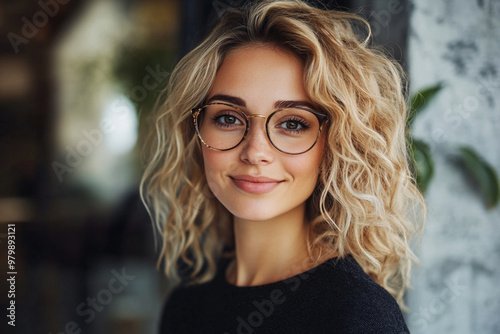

{"left": 160, "top": 256, "right": 409, "bottom": 334}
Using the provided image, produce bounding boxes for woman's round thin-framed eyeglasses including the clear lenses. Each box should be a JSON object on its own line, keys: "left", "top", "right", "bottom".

{"left": 191, "top": 102, "right": 328, "bottom": 154}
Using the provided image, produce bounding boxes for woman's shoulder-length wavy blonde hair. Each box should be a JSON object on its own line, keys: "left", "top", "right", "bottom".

{"left": 141, "top": 1, "right": 425, "bottom": 310}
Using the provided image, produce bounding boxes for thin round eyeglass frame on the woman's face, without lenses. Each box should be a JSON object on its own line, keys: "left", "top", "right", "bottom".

{"left": 191, "top": 102, "right": 328, "bottom": 155}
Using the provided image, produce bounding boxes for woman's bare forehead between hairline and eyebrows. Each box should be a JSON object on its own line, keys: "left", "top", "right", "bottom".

{"left": 208, "top": 45, "right": 310, "bottom": 108}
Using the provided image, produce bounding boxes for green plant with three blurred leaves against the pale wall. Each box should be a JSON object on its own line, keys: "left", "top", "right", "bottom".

{"left": 406, "top": 83, "right": 500, "bottom": 209}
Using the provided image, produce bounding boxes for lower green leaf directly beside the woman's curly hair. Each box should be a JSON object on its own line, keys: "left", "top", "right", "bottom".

{"left": 410, "top": 139, "right": 434, "bottom": 193}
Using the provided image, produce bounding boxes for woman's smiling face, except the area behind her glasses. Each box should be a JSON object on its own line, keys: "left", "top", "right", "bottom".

{"left": 202, "top": 46, "right": 324, "bottom": 221}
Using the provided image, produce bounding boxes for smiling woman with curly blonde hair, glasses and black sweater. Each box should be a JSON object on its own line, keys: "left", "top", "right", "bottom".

{"left": 142, "top": 1, "right": 424, "bottom": 334}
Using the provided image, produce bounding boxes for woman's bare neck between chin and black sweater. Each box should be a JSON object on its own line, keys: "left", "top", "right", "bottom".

{"left": 226, "top": 205, "right": 316, "bottom": 286}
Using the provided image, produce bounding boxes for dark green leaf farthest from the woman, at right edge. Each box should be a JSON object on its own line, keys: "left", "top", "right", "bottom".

{"left": 460, "top": 146, "right": 500, "bottom": 209}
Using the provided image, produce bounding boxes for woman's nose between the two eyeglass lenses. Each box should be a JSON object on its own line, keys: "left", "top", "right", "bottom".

{"left": 240, "top": 115, "right": 275, "bottom": 165}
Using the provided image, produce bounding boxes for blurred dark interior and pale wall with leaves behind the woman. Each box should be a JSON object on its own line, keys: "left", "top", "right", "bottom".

{"left": 0, "top": 0, "right": 500, "bottom": 334}
